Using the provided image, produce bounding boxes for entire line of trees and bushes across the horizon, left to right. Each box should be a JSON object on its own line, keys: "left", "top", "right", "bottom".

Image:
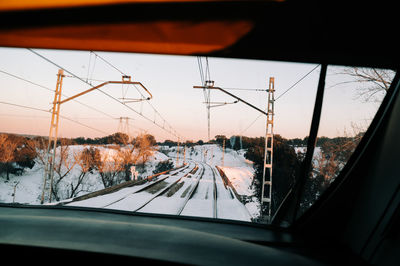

{"left": 0, "top": 132, "right": 363, "bottom": 208}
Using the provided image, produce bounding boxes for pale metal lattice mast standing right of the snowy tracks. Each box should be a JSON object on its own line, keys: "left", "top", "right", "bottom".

{"left": 261, "top": 77, "right": 275, "bottom": 219}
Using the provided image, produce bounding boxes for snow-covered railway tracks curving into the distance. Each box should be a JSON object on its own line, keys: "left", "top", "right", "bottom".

{"left": 67, "top": 162, "right": 252, "bottom": 219}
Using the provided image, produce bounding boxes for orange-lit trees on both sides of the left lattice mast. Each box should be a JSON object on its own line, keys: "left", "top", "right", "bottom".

{"left": 0, "top": 132, "right": 166, "bottom": 200}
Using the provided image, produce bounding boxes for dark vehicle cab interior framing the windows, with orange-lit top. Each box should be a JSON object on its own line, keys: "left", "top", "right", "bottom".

{"left": 0, "top": 0, "right": 400, "bottom": 265}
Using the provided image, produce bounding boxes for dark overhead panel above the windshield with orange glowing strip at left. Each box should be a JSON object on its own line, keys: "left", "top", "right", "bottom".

{"left": 0, "top": 1, "right": 399, "bottom": 69}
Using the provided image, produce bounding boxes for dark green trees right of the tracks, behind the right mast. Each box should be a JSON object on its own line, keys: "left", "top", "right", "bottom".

{"left": 212, "top": 133, "right": 363, "bottom": 216}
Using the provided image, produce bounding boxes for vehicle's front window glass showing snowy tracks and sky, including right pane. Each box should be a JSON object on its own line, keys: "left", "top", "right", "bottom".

{"left": 0, "top": 48, "right": 394, "bottom": 223}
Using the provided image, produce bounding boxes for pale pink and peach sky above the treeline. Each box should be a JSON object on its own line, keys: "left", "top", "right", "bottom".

{"left": 0, "top": 48, "right": 386, "bottom": 141}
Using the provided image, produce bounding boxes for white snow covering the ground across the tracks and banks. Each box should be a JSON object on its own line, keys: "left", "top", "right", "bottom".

{"left": 0, "top": 144, "right": 260, "bottom": 221}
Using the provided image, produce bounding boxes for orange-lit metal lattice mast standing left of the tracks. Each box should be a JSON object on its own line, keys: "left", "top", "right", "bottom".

{"left": 40, "top": 69, "right": 64, "bottom": 204}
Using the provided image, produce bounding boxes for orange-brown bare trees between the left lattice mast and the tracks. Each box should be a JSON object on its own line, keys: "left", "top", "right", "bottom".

{"left": 47, "top": 134, "right": 155, "bottom": 201}
